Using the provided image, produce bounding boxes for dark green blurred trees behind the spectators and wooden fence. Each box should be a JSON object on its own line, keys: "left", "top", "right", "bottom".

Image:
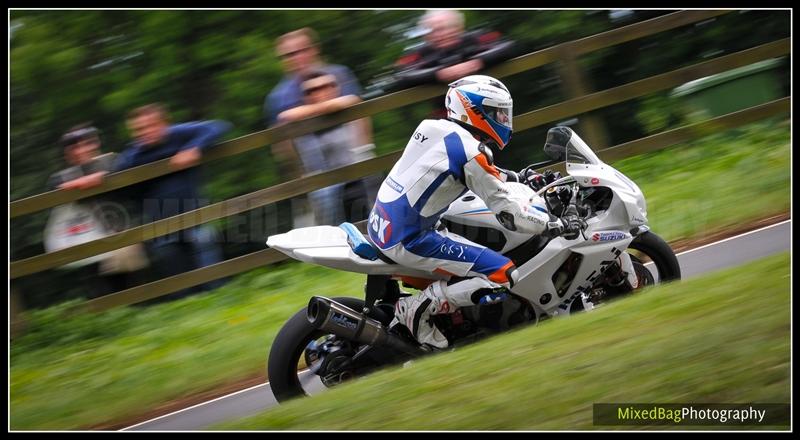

{"left": 9, "top": 10, "right": 789, "bottom": 306}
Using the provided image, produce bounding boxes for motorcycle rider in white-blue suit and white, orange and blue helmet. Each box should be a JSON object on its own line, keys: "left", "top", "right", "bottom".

{"left": 368, "top": 75, "right": 581, "bottom": 348}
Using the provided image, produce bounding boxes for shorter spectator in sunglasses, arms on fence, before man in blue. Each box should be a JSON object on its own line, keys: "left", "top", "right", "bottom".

{"left": 278, "top": 71, "right": 380, "bottom": 225}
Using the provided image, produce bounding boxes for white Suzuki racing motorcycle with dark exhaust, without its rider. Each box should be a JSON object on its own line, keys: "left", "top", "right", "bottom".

{"left": 267, "top": 127, "right": 680, "bottom": 401}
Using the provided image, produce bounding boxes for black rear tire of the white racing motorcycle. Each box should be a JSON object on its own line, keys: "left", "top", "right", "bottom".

{"left": 267, "top": 297, "right": 364, "bottom": 402}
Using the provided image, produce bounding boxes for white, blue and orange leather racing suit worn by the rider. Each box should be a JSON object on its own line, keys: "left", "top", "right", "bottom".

{"left": 368, "top": 119, "right": 558, "bottom": 346}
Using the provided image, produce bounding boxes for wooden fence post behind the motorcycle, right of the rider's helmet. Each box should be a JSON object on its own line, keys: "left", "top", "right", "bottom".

{"left": 557, "top": 44, "right": 611, "bottom": 150}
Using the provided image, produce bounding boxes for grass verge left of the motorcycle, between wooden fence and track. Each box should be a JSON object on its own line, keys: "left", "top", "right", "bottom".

{"left": 11, "top": 264, "right": 364, "bottom": 429}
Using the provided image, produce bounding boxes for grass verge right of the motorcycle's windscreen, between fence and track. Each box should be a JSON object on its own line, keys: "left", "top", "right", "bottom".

{"left": 613, "top": 119, "right": 791, "bottom": 240}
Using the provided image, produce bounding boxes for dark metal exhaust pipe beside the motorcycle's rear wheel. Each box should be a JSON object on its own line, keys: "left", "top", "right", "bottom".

{"left": 307, "top": 296, "right": 426, "bottom": 355}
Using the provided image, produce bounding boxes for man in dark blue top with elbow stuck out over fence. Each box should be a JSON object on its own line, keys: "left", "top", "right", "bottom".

{"left": 114, "top": 104, "right": 231, "bottom": 299}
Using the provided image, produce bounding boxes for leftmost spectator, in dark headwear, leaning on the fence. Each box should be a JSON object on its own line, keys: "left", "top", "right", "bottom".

{"left": 45, "top": 123, "right": 148, "bottom": 298}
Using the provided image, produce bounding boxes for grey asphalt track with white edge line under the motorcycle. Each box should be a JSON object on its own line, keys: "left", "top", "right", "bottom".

{"left": 123, "top": 220, "right": 791, "bottom": 431}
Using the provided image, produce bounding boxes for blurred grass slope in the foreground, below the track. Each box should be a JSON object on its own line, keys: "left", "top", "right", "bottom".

{"left": 214, "top": 253, "right": 790, "bottom": 430}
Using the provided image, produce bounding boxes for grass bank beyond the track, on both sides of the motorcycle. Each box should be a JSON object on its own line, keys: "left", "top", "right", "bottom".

{"left": 10, "top": 117, "right": 790, "bottom": 429}
